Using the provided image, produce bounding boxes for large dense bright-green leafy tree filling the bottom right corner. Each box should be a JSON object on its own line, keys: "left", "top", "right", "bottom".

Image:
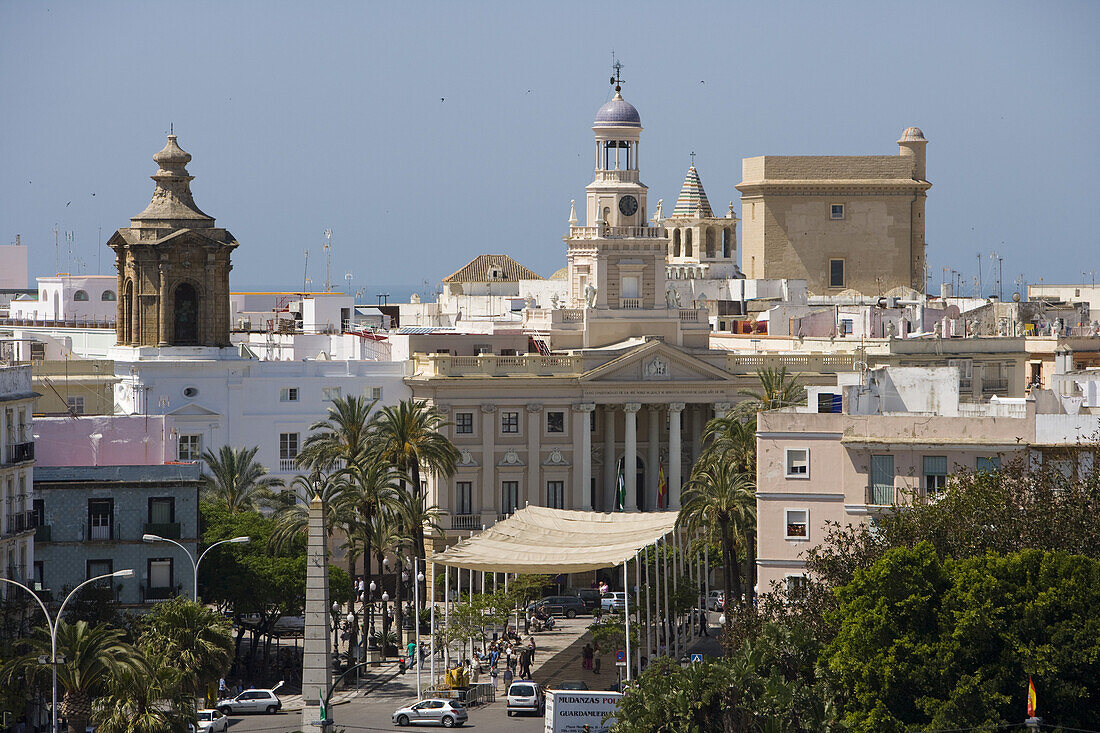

{"left": 823, "top": 543, "right": 1100, "bottom": 732}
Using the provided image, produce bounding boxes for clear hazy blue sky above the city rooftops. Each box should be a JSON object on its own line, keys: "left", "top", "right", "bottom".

{"left": 0, "top": 0, "right": 1100, "bottom": 300}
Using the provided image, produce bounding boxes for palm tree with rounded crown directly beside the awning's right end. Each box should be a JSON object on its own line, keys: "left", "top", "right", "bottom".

{"left": 677, "top": 456, "right": 756, "bottom": 647}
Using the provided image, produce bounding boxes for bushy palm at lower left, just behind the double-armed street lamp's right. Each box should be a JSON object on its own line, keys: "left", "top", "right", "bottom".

{"left": 139, "top": 597, "right": 233, "bottom": 697}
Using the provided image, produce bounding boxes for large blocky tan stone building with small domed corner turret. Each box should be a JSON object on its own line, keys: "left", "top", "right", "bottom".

{"left": 737, "top": 128, "right": 932, "bottom": 295}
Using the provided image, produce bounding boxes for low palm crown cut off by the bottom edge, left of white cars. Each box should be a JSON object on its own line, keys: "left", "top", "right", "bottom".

{"left": 92, "top": 653, "right": 198, "bottom": 733}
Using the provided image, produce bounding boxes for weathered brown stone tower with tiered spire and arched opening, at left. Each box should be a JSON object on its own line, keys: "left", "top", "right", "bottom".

{"left": 107, "top": 135, "right": 237, "bottom": 347}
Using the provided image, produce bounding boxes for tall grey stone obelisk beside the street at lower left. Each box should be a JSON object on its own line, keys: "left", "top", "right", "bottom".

{"left": 301, "top": 494, "right": 332, "bottom": 731}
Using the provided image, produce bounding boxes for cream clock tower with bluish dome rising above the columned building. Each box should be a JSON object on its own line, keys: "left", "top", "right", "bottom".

{"left": 564, "top": 62, "right": 668, "bottom": 319}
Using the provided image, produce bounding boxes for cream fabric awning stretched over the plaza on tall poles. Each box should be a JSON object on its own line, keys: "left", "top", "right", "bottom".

{"left": 428, "top": 506, "right": 677, "bottom": 575}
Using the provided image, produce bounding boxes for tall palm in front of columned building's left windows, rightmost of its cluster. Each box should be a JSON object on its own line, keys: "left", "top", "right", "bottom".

{"left": 371, "top": 400, "right": 459, "bottom": 602}
